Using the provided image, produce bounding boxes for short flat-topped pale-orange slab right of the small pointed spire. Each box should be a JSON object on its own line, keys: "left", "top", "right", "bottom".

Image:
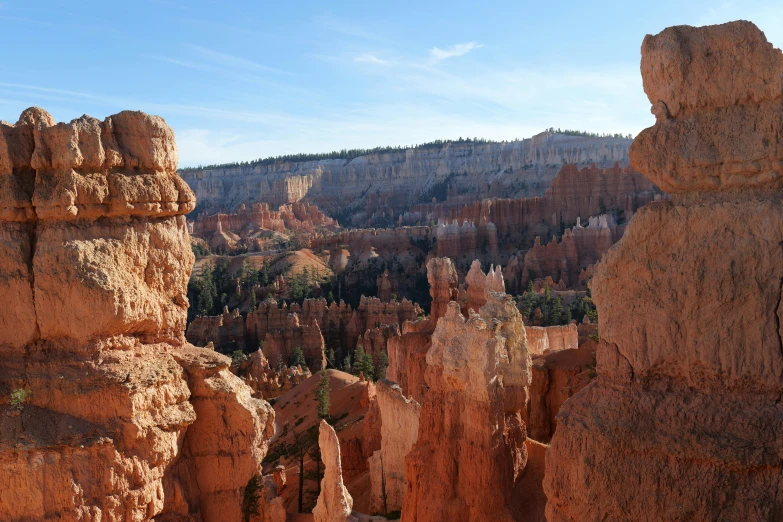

{"left": 369, "top": 380, "right": 421, "bottom": 514}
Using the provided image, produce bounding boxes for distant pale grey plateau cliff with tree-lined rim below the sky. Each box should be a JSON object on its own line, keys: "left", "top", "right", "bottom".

{"left": 182, "top": 133, "right": 630, "bottom": 224}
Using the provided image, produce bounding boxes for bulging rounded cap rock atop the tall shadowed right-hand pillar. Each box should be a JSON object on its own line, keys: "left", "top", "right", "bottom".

{"left": 631, "top": 21, "right": 783, "bottom": 193}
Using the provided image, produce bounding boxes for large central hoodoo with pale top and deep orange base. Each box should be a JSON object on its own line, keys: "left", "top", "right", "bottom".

{"left": 402, "top": 293, "right": 530, "bottom": 522}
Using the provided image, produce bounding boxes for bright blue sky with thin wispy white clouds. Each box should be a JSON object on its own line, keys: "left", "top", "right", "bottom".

{"left": 0, "top": 0, "right": 783, "bottom": 166}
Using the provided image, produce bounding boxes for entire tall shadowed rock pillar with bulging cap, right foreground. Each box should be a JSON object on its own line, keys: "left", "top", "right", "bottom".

{"left": 544, "top": 22, "right": 783, "bottom": 521}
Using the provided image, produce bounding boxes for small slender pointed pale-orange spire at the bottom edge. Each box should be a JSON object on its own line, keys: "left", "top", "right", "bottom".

{"left": 313, "top": 420, "right": 358, "bottom": 522}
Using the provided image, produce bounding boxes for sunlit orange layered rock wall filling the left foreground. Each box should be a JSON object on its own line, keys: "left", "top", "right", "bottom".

{"left": 0, "top": 109, "right": 274, "bottom": 521}
